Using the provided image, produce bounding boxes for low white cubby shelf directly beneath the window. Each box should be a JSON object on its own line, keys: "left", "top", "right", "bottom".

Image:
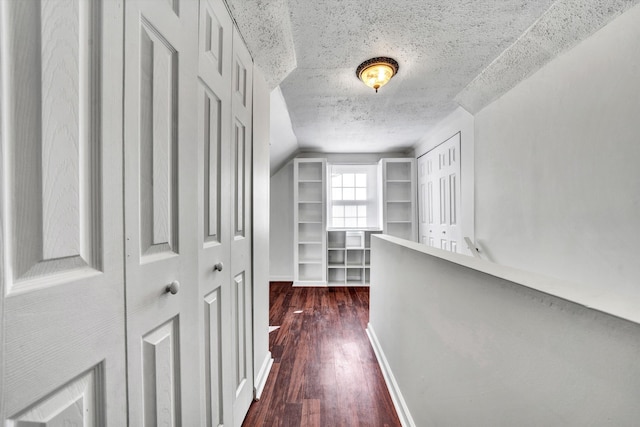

{"left": 327, "top": 230, "right": 382, "bottom": 286}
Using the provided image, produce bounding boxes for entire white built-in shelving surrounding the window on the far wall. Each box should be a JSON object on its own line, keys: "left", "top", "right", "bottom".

{"left": 294, "top": 158, "right": 417, "bottom": 286}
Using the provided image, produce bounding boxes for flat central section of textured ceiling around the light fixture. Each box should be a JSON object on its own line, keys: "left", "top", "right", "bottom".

{"left": 280, "top": 0, "right": 553, "bottom": 152}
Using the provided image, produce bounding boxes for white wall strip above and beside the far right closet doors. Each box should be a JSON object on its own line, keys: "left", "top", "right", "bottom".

{"left": 415, "top": 107, "right": 475, "bottom": 254}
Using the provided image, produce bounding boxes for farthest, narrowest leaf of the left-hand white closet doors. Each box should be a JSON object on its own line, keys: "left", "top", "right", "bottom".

{"left": 231, "top": 28, "right": 253, "bottom": 426}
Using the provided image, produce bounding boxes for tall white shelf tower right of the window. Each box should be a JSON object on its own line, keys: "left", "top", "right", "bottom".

{"left": 380, "top": 158, "right": 417, "bottom": 241}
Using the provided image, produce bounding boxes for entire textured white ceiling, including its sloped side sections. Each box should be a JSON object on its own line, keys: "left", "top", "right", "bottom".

{"left": 228, "top": 0, "right": 639, "bottom": 159}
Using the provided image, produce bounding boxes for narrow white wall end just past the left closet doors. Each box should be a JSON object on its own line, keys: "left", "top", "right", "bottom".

{"left": 252, "top": 67, "right": 273, "bottom": 393}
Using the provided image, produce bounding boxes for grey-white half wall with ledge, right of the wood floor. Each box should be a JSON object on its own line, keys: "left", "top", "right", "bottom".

{"left": 368, "top": 236, "right": 640, "bottom": 427}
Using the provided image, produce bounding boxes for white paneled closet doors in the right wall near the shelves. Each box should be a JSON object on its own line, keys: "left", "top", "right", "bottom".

{"left": 418, "top": 133, "right": 462, "bottom": 252}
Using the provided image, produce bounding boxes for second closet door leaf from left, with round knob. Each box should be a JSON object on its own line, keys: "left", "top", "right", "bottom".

{"left": 124, "top": 0, "right": 202, "bottom": 426}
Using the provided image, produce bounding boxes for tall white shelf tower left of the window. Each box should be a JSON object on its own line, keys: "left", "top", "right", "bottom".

{"left": 294, "top": 159, "right": 327, "bottom": 285}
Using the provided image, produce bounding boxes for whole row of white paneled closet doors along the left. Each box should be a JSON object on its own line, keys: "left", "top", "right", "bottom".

{"left": 0, "top": 0, "right": 254, "bottom": 427}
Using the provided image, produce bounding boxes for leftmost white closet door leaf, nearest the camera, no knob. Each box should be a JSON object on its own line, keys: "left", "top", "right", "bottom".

{"left": 0, "top": 0, "right": 127, "bottom": 426}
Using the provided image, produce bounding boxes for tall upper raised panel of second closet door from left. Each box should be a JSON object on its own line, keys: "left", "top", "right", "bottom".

{"left": 139, "top": 18, "right": 179, "bottom": 260}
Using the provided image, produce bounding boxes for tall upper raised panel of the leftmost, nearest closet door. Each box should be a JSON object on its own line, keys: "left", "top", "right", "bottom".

{"left": 4, "top": 2, "right": 101, "bottom": 291}
